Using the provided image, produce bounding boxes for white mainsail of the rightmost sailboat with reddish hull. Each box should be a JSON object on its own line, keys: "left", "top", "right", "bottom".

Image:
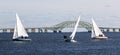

{"left": 92, "top": 19, "right": 105, "bottom": 37}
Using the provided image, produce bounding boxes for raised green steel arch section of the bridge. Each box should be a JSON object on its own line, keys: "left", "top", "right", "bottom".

{"left": 53, "top": 21, "right": 92, "bottom": 31}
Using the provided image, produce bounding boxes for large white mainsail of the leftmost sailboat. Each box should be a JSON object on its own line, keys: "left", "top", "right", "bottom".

{"left": 16, "top": 14, "right": 28, "bottom": 37}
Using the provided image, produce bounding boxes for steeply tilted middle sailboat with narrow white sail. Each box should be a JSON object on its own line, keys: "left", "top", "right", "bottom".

{"left": 64, "top": 16, "right": 80, "bottom": 42}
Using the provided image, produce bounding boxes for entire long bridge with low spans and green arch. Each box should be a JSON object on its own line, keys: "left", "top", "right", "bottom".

{"left": 0, "top": 21, "right": 120, "bottom": 32}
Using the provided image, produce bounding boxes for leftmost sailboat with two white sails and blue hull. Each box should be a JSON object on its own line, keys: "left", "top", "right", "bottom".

{"left": 13, "top": 13, "right": 31, "bottom": 41}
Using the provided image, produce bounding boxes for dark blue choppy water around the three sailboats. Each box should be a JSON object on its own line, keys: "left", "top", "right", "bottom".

{"left": 0, "top": 32, "right": 120, "bottom": 55}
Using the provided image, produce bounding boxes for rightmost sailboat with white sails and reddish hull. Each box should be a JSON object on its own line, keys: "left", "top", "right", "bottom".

{"left": 91, "top": 19, "right": 108, "bottom": 39}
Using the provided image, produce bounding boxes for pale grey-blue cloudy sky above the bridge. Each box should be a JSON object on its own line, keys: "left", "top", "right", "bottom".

{"left": 0, "top": 0, "right": 120, "bottom": 28}
